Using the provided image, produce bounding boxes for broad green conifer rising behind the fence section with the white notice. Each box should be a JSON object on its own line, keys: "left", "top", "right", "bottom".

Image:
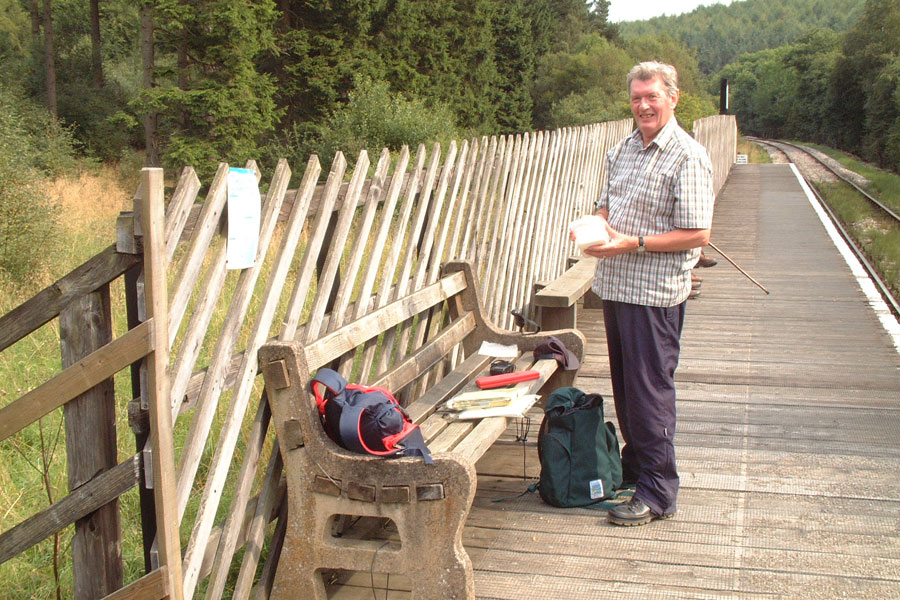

{"left": 144, "top": 0, "right": 279, "bottom": 175}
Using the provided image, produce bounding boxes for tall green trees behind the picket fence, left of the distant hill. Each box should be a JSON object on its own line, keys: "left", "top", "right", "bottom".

{"left": 0, "top": 0, "right": 714, "bottom": 175}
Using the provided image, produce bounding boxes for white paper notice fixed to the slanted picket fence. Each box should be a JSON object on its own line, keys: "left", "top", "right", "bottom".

{"left": 225, "top": 168, "right": 261, "bottom": 269}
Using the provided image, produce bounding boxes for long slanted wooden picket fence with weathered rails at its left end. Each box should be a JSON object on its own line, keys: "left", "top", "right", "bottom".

{"left": 0, "top": 117, "right": 737, "bottom": 599}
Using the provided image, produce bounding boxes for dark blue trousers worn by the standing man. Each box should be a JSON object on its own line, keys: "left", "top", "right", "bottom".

{"left": 603, "top": 300, "right": 686, "bottom": 515}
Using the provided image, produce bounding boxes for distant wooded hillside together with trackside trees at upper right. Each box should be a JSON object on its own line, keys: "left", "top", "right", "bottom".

{"left": 619, "top": 0, "right": 900, "bottom": 172}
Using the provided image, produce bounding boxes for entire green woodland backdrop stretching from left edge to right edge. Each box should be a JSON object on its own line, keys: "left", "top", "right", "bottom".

{"left": 0, "top": 0, "right": 900, "bottom": 283}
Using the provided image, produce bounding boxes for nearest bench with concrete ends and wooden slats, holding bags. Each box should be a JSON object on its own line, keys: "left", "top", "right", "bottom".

{"left": 259, "top": 263, "right": 584, "bottom": 600}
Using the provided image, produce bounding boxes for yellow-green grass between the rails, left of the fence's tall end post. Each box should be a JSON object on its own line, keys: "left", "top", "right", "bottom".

{"left": 0, "top": 162, "right": 143, "bottom": 598}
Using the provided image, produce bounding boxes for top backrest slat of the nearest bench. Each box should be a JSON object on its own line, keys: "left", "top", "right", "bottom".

{"left": 305, "top": 272, "right": 466, "bottom": 370}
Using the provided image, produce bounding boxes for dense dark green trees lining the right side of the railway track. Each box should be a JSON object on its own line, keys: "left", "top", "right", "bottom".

{"left": 716, "top": 0, "right": 900, "bottom": 171}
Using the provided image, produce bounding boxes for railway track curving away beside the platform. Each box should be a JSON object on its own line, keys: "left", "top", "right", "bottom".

{"left": 747, "top": 137, "right": 900, "bottom": 318}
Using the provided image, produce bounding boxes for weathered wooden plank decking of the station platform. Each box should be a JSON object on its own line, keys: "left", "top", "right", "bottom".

{"left": 333, "top": 165, "right": 900, "bottom": 600}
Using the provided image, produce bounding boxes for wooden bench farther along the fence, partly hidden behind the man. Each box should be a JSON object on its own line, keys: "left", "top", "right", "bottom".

{"left": 534, "top": 257, "right": 600, "bottom": 329}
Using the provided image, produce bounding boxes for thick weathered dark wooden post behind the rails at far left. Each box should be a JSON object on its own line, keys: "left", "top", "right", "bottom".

{"left": 59, "top": 285, "right": 123, "bottom": 598}
